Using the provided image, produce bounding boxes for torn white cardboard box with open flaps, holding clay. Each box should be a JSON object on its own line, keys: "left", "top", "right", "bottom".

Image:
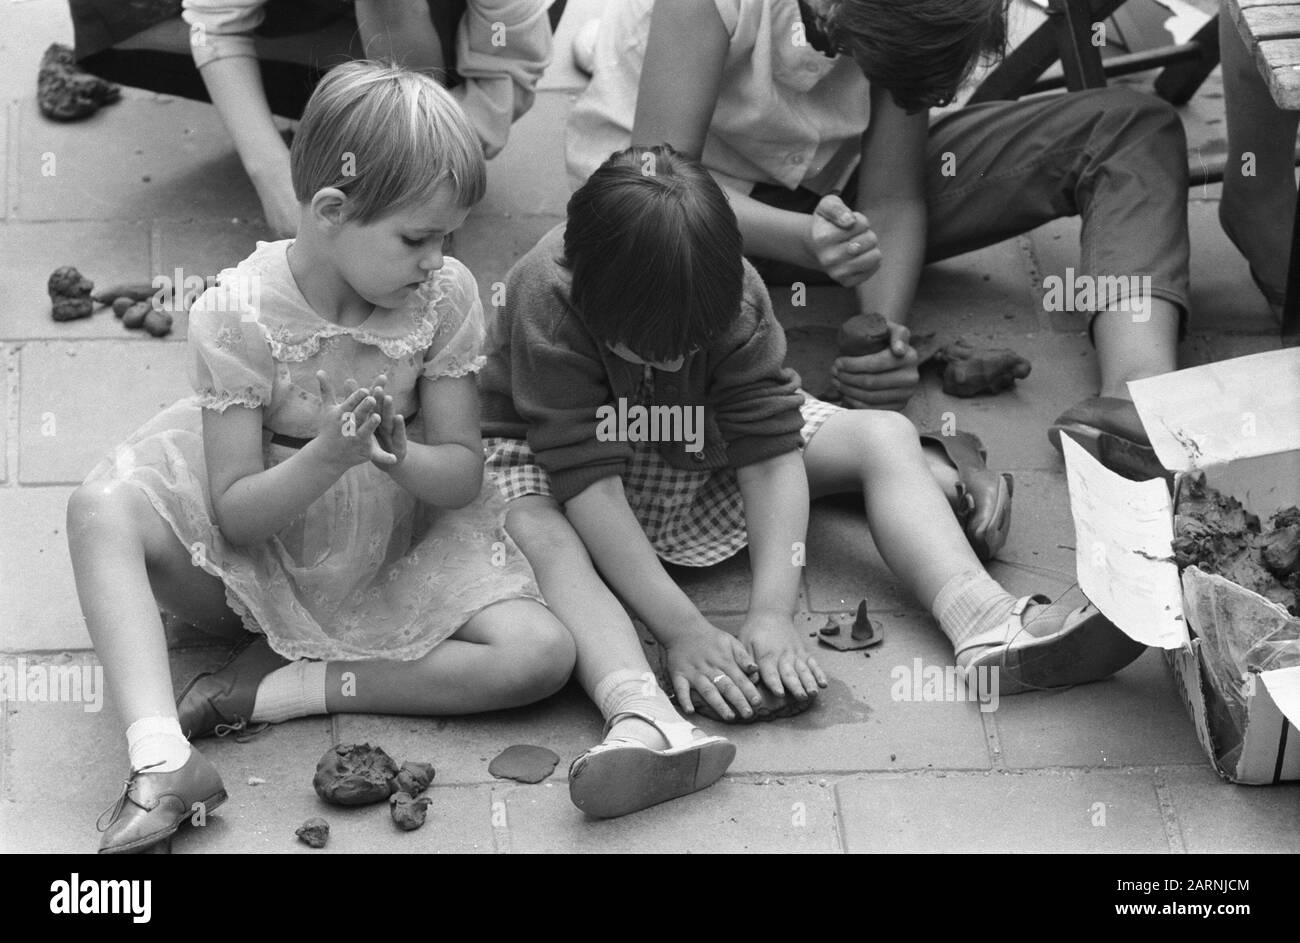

{"left": 1065, "top": 349, "right": 1300, "bottom": 784}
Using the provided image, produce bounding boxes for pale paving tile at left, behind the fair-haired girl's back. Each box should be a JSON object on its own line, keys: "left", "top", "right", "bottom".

{"left": 18, "top": 340, "right": 191, "bottom": 484}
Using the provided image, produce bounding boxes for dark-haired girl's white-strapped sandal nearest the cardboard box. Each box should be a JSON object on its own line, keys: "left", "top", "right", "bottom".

{"left": 957, "top": 596, "right": 1147, "bottom": 695}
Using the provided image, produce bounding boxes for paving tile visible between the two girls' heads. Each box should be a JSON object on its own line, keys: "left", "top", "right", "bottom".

{"left": 476, "top": 91, "right": 573, "bottom": 216}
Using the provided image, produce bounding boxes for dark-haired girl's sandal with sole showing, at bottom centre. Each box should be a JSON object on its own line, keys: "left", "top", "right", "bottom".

{"left": 569, "top": 710, "right": 736, "bottom": 818}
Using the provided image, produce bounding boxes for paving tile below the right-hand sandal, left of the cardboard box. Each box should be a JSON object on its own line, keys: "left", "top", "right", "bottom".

{"left": 993, "top": 649, "right": 1208, "bottom": 769}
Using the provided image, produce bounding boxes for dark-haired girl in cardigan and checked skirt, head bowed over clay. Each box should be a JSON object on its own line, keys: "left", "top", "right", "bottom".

{"left": 480, "top": 147, "right": 1141, "bottom": 814}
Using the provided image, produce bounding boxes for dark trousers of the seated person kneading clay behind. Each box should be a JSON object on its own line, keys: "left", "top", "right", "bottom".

{"left": 751, "top": 87, "right": 1188, "bottom": 312}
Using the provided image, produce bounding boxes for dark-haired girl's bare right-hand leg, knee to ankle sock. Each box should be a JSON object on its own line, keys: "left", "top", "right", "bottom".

{"left": 803, "top": 410, "right": 983, "bottom": 607}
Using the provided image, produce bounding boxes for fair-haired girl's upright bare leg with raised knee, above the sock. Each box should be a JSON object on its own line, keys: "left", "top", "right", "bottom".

{"left": 68, "top": 481, "right": 243, "bottom": 726}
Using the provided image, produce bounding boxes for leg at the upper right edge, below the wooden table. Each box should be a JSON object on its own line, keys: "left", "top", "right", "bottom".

{"left": 1219, "top": 13, "right": 1300, "bottom": 309}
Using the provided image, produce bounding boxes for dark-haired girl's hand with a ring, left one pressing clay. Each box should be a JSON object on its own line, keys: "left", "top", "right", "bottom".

{"left": 668, "top": 623, "right": 763, "bottom": 721}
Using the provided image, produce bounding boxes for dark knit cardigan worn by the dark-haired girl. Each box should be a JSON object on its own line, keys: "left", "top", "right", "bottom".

{"left": 478, "top": 225, "right": 803, "bottom": 502}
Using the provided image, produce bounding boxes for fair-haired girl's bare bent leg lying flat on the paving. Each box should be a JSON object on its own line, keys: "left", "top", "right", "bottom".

{"left": 325, "top": 600, "right": 573, "bottom": 715}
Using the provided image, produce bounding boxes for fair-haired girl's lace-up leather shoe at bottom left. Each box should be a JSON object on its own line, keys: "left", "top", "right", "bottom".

{"left": 96, "top": 747, "right": 226, "bottom": 855}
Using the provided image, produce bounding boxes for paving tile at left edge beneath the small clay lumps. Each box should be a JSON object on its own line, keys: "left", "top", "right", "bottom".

{"left": 0, "top": 221, "right": 152, "bottom": 341}
